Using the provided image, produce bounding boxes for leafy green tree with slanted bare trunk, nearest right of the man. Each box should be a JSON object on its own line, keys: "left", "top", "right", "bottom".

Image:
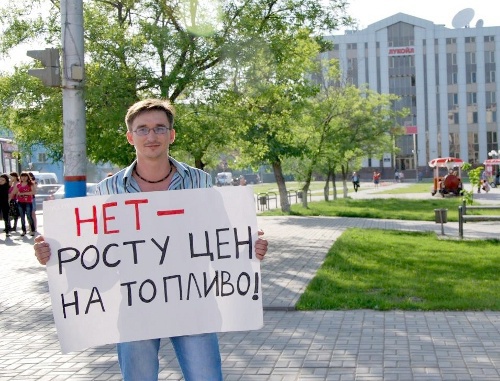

{"left": 230, "top": 30, "right": 319, "bottom": 212}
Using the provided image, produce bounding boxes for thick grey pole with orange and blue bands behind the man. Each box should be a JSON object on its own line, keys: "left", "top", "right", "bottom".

{"left": 61, "top": 0, "right": 87, "bottom": 197}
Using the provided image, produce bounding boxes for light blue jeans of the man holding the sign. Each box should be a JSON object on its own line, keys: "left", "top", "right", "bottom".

{"left": 116, "top": 333, "right": 222, "bottom": 381}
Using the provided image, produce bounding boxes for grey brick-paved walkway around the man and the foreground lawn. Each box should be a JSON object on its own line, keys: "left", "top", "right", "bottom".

{"left": 0, "top": 209, "right": 500, "bottom": 381}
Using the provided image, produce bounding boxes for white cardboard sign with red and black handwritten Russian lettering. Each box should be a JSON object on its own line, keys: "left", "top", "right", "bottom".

{"left": 43, "top": 187, "right": 263, "bottom": 353}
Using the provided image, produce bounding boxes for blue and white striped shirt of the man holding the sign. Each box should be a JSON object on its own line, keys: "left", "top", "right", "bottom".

{"left": 96, "top": 157, "right": 212, "bottom": 195}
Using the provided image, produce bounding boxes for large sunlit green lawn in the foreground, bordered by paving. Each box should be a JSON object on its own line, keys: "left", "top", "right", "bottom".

{"left": 297, "top": 229, "right": 500, "bottom": 311}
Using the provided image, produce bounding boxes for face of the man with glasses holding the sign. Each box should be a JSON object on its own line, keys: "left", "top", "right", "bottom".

{"left": 127, "top": 110, "right": 175, "bottom": 159}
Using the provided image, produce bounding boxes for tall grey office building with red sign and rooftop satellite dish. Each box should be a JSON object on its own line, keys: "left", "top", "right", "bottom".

{"left": 326, "top": 9, "right": 500, "bottom": 173}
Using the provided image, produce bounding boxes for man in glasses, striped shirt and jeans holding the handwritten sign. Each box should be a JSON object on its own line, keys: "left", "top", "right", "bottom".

{"left": 35, "top": 99, "right": 267, "bottom": 381}
